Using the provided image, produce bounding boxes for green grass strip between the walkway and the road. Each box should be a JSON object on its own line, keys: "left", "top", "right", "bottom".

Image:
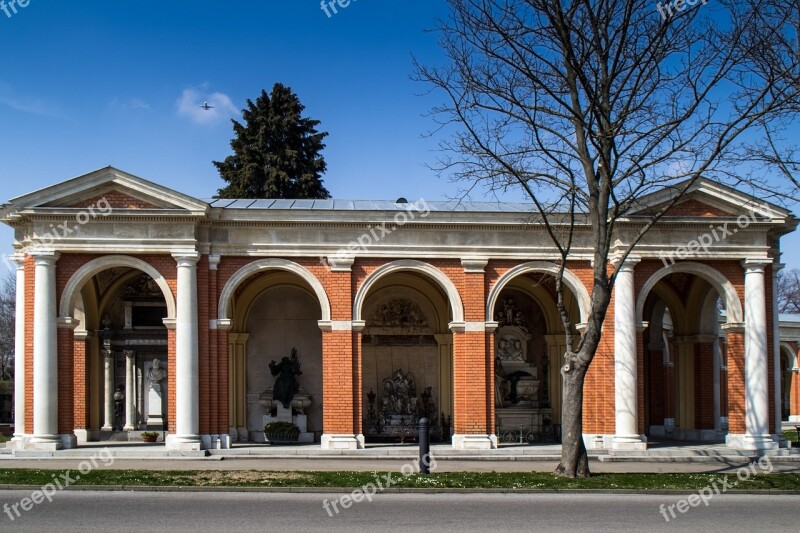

{"left": 0, "top": 469, "right": 800, "bottom": 493}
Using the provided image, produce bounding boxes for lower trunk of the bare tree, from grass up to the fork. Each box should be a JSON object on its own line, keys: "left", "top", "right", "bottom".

{"left": 555, "top": 354, "right": 590, "bottom": 478}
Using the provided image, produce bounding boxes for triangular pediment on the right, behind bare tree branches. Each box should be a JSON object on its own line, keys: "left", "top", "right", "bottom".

{"left": 631, "top": 179, "right": 791, "bottom": 220}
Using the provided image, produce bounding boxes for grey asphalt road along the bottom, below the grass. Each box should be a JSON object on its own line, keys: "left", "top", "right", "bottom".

{"left": 0, "top": 491, "right": 800, "bottom": 533}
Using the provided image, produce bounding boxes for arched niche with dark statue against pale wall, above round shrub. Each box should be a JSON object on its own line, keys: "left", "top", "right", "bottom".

{"left": 221, "top": 267, "right": 327, "bottom": 443}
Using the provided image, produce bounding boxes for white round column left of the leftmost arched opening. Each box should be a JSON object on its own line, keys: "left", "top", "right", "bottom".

{"left": 31, "top": 250, "right": 61, "bottom": 450}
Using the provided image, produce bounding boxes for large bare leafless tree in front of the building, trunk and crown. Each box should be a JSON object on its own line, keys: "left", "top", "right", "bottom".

{"left": 416, "top": 0, "right": 800, "bottom": 477}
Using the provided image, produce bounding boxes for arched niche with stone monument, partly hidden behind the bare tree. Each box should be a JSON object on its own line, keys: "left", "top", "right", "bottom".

{"left": 491, "top": 271, "right": 581, "bottom": 445}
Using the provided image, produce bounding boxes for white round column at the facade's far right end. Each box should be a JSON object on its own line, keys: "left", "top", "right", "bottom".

{"left": 742, "top": 259, "right": 778, "bottom": 450}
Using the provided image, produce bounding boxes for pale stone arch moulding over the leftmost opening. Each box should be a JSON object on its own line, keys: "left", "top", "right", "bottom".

{"left": 59, "top": 255, "right": 176, "bottom": 320}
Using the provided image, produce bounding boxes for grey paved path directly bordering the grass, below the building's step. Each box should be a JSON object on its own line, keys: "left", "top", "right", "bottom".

{"left": 0, "top": 456, "right": 800, "bottom": 474}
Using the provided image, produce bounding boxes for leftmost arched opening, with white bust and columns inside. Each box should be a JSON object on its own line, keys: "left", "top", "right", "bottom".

{"left": 67, "top": 266, "right": 174, "bottom": 442}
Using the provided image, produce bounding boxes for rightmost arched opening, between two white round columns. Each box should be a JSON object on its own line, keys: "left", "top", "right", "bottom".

{"left": 637, "top": 265, "right": 741, "bottom": 442}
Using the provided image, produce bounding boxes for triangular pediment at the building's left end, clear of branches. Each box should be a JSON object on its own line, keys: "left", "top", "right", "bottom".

{"left": 5, "top": 167, "right": 209, "bottom": 214}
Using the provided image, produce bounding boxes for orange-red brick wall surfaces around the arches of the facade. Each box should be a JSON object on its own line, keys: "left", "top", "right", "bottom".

{"left": 25, "top": 245, "right": 776, "bottom": 440}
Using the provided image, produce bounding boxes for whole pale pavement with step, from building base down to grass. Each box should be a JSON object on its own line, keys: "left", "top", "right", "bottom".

{"left": 0, "top": 442, "right": 800, "bottom": 473}
